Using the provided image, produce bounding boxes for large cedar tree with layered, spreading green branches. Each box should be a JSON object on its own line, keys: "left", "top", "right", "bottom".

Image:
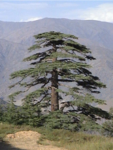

{"left": 10, "top": 31, "right": 109, "bottom": 130}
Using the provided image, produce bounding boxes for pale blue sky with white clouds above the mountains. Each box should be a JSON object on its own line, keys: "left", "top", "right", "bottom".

{"left": 0, "top": 0, "right": 113, "bottom": 22}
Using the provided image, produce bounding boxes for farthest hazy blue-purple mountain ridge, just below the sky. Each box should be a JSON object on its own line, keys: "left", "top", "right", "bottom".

{"left": 0, "top": 18, "right": 113, "bottom": 49}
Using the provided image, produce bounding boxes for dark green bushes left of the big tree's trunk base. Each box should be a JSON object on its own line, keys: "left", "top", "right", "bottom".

{"left": 0, "top": 100, "right": 45, "bottom": 126}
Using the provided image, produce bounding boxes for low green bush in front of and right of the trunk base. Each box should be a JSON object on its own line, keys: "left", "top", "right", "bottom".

{"left": 44, "top": 111, "right": 100, "bottom": 132}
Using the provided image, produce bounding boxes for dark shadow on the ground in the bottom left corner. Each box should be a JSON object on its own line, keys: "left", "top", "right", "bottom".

{"left": 0, "top": 140, "right": 25, "bottom": 150}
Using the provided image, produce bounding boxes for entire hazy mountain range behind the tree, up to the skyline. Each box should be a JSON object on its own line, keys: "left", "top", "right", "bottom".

{"left": 0, "top": 18, "right": 113, "bottom": 106}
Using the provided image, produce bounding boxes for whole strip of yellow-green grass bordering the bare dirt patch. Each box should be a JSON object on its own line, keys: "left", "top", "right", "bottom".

{"left": 0, "top": 123, "right": 113, "bottom": 150}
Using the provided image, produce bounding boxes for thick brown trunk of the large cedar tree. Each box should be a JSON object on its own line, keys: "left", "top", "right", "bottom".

{"left": 51, "top": 58, "right": 59, "bottom": 111}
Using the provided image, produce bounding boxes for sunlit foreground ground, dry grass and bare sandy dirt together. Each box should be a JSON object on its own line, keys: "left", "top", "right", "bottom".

{"left": 0, "top": 123, "right": 113, "bottom": 150}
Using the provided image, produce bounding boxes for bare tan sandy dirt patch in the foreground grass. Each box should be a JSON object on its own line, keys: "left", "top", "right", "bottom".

{"left": 0, "top": 131, "right": 65, "bottom": 150}
